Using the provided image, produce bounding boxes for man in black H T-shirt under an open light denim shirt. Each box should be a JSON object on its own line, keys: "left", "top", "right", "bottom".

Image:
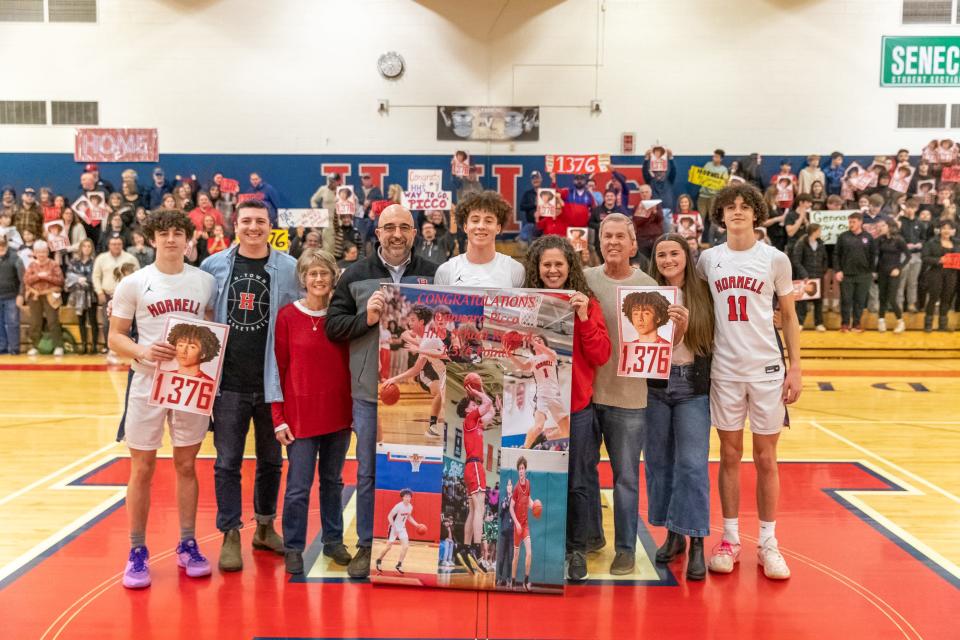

{"left": 200, "top": 200, "right": 304, "bottom": 571}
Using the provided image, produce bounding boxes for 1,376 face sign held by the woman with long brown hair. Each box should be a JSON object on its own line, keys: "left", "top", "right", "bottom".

{"left": 614, "top": 287, "right": 677, "bottom": 380}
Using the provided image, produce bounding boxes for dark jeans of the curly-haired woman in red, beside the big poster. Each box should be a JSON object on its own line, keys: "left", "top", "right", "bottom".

{"left": 567, "top": 405, "right": 600, "bottom": 551}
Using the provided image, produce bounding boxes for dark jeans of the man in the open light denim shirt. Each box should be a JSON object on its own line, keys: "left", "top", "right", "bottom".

{"left": 213, "top": 391, "right": 283, "bottom": 532}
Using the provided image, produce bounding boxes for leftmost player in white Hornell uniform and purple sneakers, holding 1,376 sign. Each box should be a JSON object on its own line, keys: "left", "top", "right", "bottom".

{"left": 109, "top": 209, "right": 217, "bottom": 589}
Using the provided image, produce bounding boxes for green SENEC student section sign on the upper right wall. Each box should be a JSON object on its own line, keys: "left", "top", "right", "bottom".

{"left": 880, "top": 36, "right": 960, "bottom": 87}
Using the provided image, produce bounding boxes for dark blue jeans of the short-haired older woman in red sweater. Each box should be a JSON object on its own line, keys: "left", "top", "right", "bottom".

{"left": 283, "top": 429, "right": 350, "bottom": 551}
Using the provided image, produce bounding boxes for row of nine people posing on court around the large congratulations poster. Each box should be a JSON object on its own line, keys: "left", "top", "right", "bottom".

{"left": 109, "top": 180, "right": 800, "bottom": 588}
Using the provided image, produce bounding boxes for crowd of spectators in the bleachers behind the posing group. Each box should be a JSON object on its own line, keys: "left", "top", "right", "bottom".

{"left": 0, "top": 140, "right": 960, "bottom": 355}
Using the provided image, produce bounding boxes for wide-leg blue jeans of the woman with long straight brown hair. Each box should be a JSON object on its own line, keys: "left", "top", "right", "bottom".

{"left": 643, "top": 367, "right": 710, "bottom": 538}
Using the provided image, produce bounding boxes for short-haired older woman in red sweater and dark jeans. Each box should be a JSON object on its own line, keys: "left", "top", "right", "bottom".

{"left": 270, "top": 249, "right": 353, "bottom": 574}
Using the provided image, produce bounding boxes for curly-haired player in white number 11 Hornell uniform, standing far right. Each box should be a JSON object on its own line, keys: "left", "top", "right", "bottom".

{"left": 697, "top": 184, "right": 800, "bottom": 580}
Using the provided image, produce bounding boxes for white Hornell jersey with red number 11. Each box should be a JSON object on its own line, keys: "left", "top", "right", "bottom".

{"left": 697, "top": 242, "right": 793, "bottom": 382}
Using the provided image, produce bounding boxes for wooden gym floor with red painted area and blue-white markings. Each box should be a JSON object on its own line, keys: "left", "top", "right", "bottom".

{"left": 0, "top": 350, "right": 960, "bottom": 640}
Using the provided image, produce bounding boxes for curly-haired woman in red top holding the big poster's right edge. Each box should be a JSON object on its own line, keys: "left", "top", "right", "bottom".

{"left": 524, "top": 236, "right": 611, "bottom": 581}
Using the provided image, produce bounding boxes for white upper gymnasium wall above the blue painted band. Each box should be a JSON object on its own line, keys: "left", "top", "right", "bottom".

{"left": 0, "top": 0, "right": 960, "bottom": 155}
